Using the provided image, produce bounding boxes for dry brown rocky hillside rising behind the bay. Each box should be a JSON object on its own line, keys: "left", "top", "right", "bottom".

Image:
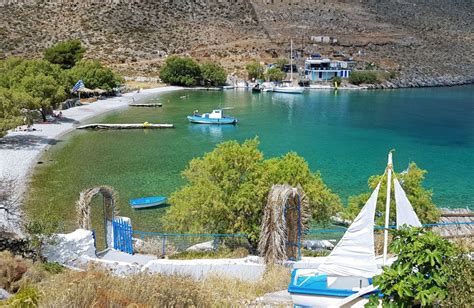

{"left": 0, "top": 0, "right": 474, "bottom": 86}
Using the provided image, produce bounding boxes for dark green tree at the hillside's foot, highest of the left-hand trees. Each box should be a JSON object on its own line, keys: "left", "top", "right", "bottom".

{"left": 43, "top": 40, "right": 86, "bottom": 69}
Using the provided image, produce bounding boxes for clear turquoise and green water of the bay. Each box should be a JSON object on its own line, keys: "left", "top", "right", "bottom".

{"left": 28, "top": 86, "right": 474, "bottom": 230}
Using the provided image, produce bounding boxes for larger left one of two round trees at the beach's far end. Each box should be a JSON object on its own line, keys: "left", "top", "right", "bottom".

{"left": 160, "top": 56, "right": 202, "bottom": 87}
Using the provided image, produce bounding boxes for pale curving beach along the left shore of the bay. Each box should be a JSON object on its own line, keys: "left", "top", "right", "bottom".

{"left": 0, "top": 87, "right": 181, "bottom": 231}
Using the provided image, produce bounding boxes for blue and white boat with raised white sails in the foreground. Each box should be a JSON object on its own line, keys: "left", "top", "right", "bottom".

{"left": 288, "top": 153, "right": 421, "bottom": 307}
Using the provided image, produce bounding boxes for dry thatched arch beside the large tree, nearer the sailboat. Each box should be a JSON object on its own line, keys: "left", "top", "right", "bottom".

{"left": 258, "top": 184, "right": 311, "bottom": 263}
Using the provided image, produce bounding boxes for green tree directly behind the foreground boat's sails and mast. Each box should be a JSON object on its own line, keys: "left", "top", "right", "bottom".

{"left": 342, "top": 162, "right": 440, "bottom": 225}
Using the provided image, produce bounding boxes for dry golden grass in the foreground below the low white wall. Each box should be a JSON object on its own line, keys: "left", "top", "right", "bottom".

{"left": 39, "top": 267, "right": 290, "bottom": 307}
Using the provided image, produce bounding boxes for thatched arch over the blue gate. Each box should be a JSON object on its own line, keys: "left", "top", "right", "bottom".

{"left": 76, "top": 186, "right": 119, "bottom": 230}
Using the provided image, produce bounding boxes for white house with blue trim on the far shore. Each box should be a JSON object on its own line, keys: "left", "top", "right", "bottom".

{"left": 304, "top": 57, "right": 351, "bottom": 81}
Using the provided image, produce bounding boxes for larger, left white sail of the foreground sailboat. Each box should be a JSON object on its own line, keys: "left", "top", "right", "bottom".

{"left": 318, "top": 183, "right": 380, "bottom": 278}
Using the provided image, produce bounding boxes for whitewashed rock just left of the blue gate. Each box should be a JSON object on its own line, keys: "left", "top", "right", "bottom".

{"left": 42, "top": 229, "right": 96, "bottom": 267}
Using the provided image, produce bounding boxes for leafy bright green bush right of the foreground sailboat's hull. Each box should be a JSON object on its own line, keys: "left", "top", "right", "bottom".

{"left": 370, "top": 228, "right": 458, "bottom": 307}
